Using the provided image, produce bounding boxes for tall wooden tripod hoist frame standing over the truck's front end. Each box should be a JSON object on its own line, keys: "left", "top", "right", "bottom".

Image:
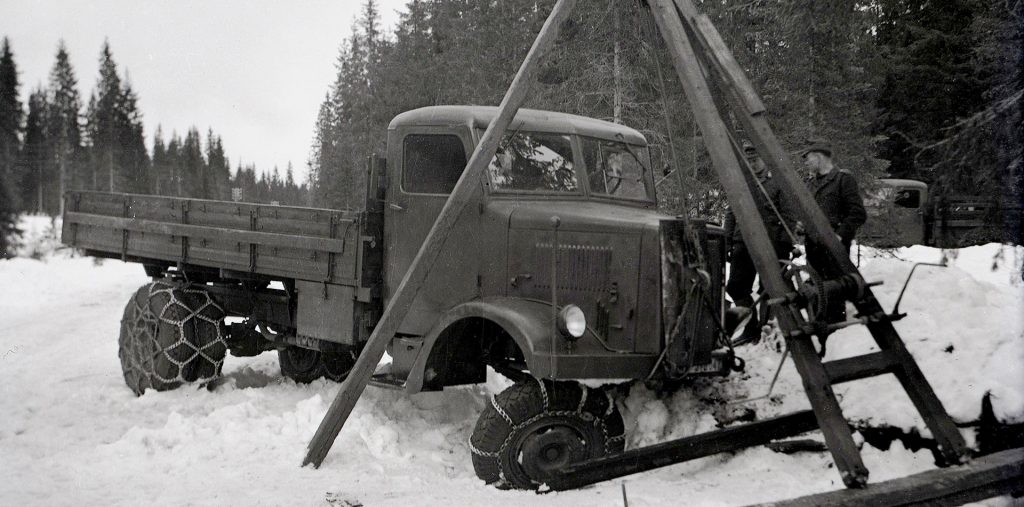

{"left": 303, "top": 0, "right": 968, "bottom": 489}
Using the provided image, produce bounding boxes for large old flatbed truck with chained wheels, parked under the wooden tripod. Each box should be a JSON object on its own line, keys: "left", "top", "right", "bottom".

{"left": 62, "top": 107, "right": 738, "bottom": 488}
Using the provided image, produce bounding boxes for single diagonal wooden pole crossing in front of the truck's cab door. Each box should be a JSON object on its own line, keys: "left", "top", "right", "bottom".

{"left": 302, "top": 0, "right": 575, "bottom": 467}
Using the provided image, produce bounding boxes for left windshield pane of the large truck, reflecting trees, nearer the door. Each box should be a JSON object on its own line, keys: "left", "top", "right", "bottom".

{"left": 487, "top": 132, "right": 580, "bottom": 193}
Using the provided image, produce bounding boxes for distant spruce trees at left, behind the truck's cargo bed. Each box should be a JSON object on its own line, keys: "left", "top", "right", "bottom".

{"left": 0, "top": 42, "right": 307, "bottom": 226}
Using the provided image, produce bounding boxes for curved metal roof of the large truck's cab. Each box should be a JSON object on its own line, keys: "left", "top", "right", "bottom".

{"left": 388, "top": 105, "right": 647, "bottom": 145}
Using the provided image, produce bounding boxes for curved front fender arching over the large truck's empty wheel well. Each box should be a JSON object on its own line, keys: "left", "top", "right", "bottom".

{"left": 406, "top": 297, "right": 553, "bottom": 393}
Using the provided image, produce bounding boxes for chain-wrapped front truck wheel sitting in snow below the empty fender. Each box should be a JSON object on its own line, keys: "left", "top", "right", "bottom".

{"left": 469, "top": 379, "right": 626, "bottom": 490}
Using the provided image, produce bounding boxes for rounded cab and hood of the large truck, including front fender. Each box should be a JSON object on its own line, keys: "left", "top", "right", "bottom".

{"left": 382, "top": 105, "right": 723, "bottom": 392}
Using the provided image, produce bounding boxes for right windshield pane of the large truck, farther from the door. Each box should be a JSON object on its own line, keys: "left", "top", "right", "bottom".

{"left": 583, "top": 137, "right": 650, "bottom": 201}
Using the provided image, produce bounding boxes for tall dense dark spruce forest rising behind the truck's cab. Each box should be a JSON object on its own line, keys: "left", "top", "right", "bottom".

{"left": 309, "top": 0, "right": 1024, "bottom": 217}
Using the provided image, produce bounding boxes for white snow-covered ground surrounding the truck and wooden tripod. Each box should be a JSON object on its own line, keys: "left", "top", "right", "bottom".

{"left": 0, "top": 218, "right": 1024, "bottom": 506}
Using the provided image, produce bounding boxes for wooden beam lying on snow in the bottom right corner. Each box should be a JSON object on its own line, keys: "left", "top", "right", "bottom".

{"left": 761, "top": 449, "right": 1024, "bottom": 507}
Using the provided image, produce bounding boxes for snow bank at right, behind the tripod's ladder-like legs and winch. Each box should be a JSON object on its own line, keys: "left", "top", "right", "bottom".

{"left": 626, "top": 244, "right": 1024, "bottom": 445}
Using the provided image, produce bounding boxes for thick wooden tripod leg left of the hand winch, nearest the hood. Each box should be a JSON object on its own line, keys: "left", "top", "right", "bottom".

{"left": 648, "top": 0, "right": 867, "bottom": 487}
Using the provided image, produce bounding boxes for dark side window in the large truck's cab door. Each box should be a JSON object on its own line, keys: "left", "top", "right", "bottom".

{"left": 401, "top": 134, "right": 466, "bottom": 194}
